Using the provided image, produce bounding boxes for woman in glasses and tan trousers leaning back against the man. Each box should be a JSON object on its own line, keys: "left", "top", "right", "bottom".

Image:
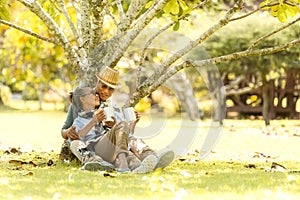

{"left": 72, "top": 84, "right": 131, "bottom": 172}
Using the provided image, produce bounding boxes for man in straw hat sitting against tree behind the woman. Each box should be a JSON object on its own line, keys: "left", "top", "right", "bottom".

{"left": 62, "top": 67, "right": 174, "bottom": 173}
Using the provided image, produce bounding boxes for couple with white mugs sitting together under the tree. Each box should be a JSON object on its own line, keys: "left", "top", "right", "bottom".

{"left": 61, "top": 67, "right": 174, "bottom": 173}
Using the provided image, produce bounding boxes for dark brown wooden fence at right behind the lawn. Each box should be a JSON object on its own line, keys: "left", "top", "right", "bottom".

{"left": 224, "top": 69, "right": 300, "bottom": 123}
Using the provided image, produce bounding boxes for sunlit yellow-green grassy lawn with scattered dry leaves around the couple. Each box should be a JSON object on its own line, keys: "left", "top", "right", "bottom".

{"left": 0, "top": 106, "right": 300, "bottom": 199}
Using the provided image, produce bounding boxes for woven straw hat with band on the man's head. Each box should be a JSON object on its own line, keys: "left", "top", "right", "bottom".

{"left": 96, "top": 66, "right": 119, "bottom": 88}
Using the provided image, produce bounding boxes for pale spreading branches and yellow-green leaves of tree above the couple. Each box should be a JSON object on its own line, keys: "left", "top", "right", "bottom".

{"left": 0, "top": 0, "right": 300, "bottom": 119}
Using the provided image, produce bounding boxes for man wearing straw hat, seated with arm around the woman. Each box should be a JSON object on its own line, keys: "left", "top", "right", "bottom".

{"left": 61, "top": 67, "right": 174, "bottom": 173}
